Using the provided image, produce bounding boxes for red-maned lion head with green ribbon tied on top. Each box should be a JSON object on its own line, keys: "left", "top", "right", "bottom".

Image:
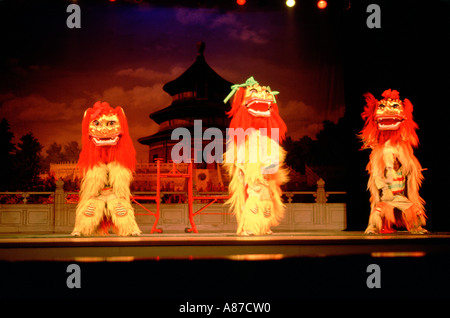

{"left": 224, "top": 76, "right": 287, "bottom": 142}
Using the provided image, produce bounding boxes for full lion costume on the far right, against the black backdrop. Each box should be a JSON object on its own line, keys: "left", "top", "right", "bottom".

{"left": 360, "top": 89, "right": 427, "bottom": 234}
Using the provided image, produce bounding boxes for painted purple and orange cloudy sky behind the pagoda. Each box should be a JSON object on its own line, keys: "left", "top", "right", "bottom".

{"left": 0, "top": 0, "right": 344, "bottom": 160}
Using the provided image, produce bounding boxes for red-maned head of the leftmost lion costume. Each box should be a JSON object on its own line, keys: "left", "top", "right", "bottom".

{"left": 78, "top": 101, "right": 136, "bottom": 171}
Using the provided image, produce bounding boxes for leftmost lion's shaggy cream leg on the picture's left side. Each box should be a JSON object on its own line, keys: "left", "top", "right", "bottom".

{"left": 72, "top": 199, "right": 105, "bottom": 236}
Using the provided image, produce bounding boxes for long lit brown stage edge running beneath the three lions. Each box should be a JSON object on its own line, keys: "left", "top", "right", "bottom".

{"left": 0, "top": 231, "right": 450, "bottom": 262}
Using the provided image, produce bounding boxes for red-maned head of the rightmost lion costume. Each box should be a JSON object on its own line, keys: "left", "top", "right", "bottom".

{"left": 360, "top": 89, "right": 419, "bottom": 149}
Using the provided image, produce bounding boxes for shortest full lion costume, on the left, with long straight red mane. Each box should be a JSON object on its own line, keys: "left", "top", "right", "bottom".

{"left": 72, "top": 102, "right": 141, "bottom": 236}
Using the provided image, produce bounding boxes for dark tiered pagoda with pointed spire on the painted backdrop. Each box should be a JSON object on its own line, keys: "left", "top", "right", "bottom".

{"left": 138, "top": 42, "right": 233, "bottom": 168}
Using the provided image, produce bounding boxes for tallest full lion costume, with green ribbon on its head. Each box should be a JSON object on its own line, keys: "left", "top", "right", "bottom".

{"left": 224, "top": 77, "right": 288, "bottom": 235}
